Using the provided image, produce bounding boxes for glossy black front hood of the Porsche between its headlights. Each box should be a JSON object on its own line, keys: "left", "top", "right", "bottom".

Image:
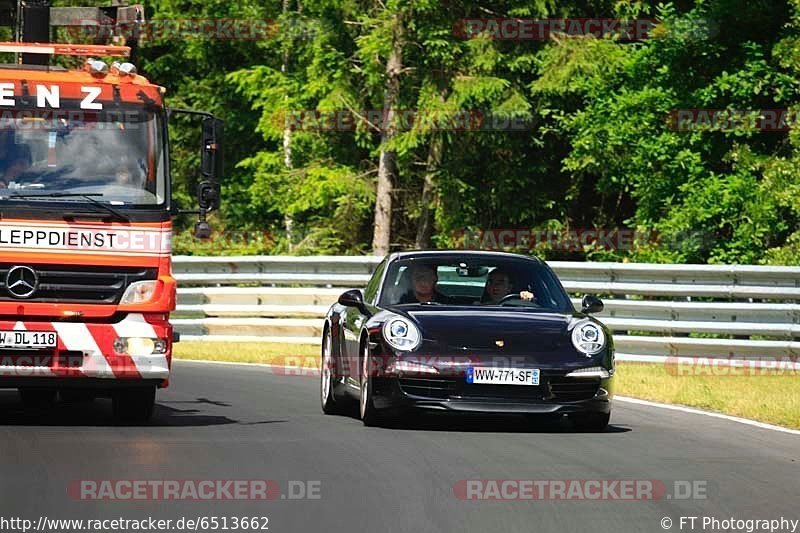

{"left": 388, "top": 308, "right": 590, "bottom": 366}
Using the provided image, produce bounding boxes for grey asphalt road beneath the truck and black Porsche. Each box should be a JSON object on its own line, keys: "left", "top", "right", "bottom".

{"left": 0, "top": 362, "right": 800, "bottom": 532}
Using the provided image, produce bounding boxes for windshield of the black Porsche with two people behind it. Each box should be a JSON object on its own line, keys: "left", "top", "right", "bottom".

{"left": 380, "top": 257, "right": 574, "bottom": 313}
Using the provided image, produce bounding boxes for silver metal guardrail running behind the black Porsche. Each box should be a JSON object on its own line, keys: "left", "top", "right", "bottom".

{"left": 173, "top": 256, "right": 800, "bottom": 360}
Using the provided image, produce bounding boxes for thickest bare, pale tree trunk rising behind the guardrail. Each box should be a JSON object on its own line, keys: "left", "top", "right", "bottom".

{"left": 372, "top": 14, "right": 403, "bottom": 255}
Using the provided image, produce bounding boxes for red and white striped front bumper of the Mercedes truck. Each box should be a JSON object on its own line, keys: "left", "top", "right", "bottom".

{"left": 0, "top": 314, "right": 172, "bottom": 380}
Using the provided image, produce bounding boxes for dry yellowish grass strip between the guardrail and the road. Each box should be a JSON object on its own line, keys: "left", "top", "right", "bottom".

{"left": 175, "top": 342, "right": 800, "bottom": 429}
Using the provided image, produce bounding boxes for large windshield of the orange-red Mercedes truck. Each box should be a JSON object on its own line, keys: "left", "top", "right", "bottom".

{"left": 0, "top": 105, "right": 166, "bottom": 206}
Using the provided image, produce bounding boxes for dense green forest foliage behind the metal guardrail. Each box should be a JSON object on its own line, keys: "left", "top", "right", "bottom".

{"left": 56, "top": 0, "right": 800, "bottom": 264}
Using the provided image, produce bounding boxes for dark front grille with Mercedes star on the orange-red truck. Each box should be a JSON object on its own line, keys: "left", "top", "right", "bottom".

{"left": 0, "top": 263, "right": 157, "bottom": 304}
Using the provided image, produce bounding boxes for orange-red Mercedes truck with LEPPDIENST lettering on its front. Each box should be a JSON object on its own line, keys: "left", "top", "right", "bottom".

{"left": 0, "top": 0, "right": 223, "bottom": 422}
